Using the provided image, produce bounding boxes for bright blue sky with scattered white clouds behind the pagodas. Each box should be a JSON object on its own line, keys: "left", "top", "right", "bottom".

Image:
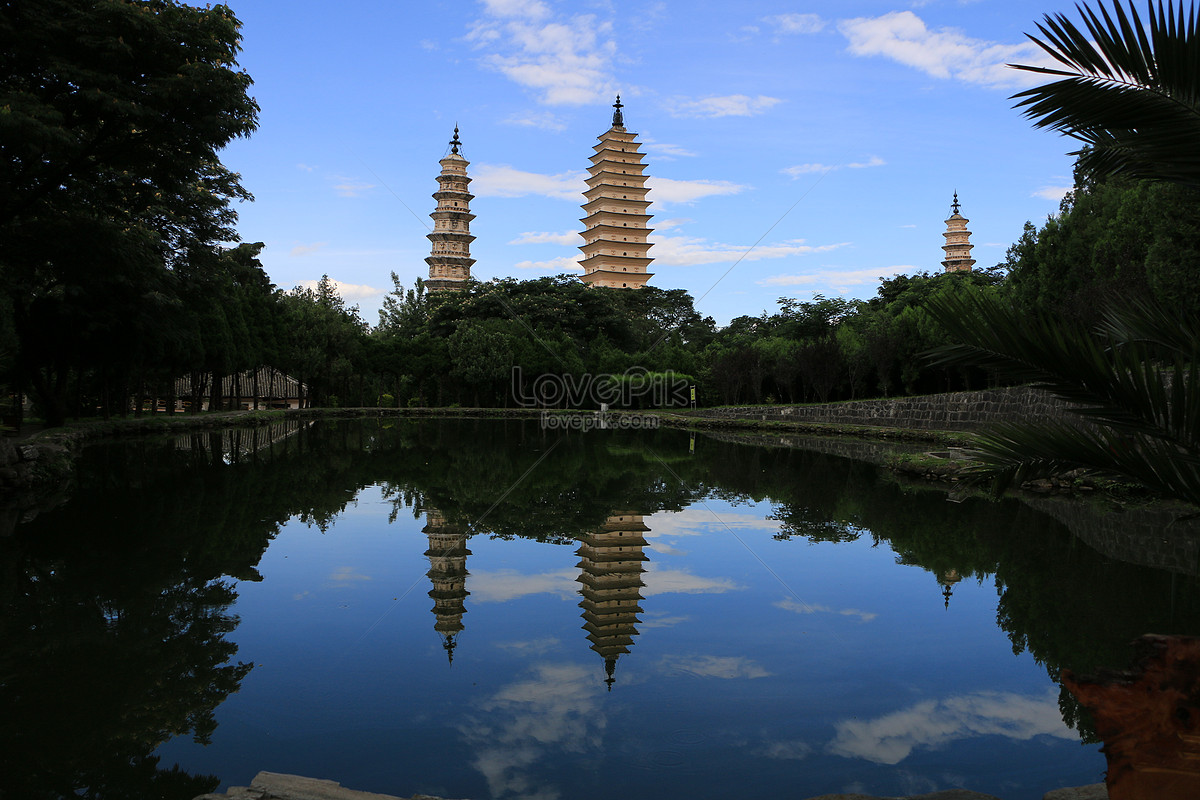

{"left": 222, "top": 0, "right": 1078, "bottom": 325}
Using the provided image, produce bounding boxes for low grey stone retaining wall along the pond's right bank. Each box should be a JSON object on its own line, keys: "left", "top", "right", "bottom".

{"left": 697, "top": 386, "right": 1068, "bottom": 431}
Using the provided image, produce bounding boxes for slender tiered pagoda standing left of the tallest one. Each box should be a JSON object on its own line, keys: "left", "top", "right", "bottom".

{"left": 425, "top": 126, "right": 475, "bottom": 291}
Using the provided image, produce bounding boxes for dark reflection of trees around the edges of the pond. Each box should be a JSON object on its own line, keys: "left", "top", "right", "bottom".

{"left": 0, "top": 420, "right": 1200, "bottom": 799}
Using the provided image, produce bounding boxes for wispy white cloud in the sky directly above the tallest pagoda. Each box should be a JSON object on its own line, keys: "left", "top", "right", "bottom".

{"left": 467, "top": 0, "right": 617, "bottom": 106}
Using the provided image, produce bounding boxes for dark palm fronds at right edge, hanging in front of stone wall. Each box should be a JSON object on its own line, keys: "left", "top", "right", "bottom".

{"left": 925, "top": 293, "right": 1200, "bottom": 503}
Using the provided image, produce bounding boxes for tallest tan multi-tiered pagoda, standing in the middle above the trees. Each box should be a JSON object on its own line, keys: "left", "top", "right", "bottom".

{"left": 580, "top": 95, "right": 654, "bottom": 289}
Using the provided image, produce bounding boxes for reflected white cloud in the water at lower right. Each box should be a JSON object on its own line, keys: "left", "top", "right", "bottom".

{"left": 829, "top": 691, "right": 1078, "bottom": 764}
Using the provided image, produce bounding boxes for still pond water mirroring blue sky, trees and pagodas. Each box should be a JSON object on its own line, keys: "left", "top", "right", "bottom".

{"left": 9, "top": 420, "right": 1200, "bottom": 800}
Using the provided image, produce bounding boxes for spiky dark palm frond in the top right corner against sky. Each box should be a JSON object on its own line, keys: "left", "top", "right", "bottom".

{"left": 1010, "top": 1, "right": 1200, "bottom": 186}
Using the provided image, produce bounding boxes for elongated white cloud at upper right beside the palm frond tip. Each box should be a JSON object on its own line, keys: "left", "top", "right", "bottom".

{"left": 838, "top": 11, "right": 1050, "bottom": 88}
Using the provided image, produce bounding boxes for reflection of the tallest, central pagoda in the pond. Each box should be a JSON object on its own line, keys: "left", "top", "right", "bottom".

{"left": 576, "top": 511, "right": 649, "bottom": 691}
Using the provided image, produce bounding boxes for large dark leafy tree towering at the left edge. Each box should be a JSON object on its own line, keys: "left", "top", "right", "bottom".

{"left": 0, "top": 0, "right": 258, "bottom": 425}
